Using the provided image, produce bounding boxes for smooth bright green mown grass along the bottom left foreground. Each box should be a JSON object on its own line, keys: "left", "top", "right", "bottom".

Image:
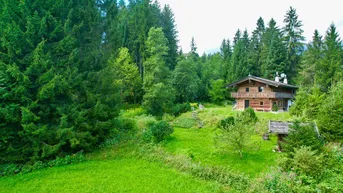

{"left": 0, "top": 159, "right": 221, "bottom": 193}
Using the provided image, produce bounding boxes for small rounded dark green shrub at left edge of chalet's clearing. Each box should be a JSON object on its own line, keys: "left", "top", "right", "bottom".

{"left": 149, "top": 121, "right": 174, "bottom": 143}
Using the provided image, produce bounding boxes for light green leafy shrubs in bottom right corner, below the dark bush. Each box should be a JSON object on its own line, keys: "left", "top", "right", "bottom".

{"left": 253, "top": 144, "right": 343, "bottom": 192}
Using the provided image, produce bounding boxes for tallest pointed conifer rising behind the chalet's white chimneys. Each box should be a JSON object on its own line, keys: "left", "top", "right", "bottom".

{"left": 283, "top": 7, "right": 305, "bottom": 81}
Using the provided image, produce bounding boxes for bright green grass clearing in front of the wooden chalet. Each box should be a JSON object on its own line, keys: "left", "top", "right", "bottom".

{"left": 165, "top": 106, "right": 292, "bottom": 177}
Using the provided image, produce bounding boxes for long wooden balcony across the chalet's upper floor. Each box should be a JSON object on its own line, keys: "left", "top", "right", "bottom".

{"left": 231, "top": 92, "right": 294, "bottom": 99}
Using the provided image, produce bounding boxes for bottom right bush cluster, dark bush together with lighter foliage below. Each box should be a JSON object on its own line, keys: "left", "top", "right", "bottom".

{"left": 250, "top": 121, "right": 343, "bottom": 192}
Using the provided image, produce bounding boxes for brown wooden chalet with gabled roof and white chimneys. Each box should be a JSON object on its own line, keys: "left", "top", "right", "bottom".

{"left": 227, "top": 75, "right": 298, "bottom": 111}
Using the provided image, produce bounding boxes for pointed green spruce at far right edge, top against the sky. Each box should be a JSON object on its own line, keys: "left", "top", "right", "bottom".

{"left": 316, "top": 24, "right": 343, "bottom": 92}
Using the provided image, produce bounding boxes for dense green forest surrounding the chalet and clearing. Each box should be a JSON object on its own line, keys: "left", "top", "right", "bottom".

{"left": 0, "top": 0, "right": 343, "bottom": 167}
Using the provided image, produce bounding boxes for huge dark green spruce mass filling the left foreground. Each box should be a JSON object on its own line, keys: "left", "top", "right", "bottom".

{"left": 0, "top": 0, "right": 119, "bottom": 163}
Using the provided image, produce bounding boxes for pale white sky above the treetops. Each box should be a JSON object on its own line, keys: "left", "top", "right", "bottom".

{"left": 159, "top": 0, "right": 343, "bottom": 54}
